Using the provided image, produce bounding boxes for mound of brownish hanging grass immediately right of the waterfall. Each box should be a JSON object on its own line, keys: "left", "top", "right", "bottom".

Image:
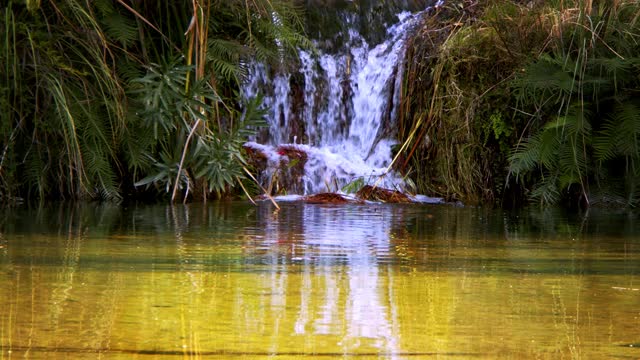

{"left": 398, "top": 1, "right": 551, "bottom": 203}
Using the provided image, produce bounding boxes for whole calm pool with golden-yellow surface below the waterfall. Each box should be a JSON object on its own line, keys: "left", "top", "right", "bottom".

{"left": 0, "top": 204, "right": 640, "bottom": 359}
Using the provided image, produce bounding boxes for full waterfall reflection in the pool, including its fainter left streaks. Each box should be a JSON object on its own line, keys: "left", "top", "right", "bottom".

{"left": 254, "top": 205, "right": 402, "bottom": 354}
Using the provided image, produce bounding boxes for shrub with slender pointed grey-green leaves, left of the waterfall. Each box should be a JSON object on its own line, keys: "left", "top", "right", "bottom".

{"left": 133, "top": 63, "right": 265, "bottom": 197}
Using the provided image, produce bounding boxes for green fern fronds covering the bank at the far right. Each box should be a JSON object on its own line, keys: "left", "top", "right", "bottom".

{"left": 510, "top": 3, "right": 640, "bottom": 205}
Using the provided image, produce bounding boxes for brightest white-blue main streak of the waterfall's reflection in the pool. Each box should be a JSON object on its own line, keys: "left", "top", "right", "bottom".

{"left": 302, "top": 206, "right": 397, "bottom": 353}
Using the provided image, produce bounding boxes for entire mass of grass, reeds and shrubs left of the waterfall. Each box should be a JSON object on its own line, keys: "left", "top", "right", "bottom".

{"left": 0, "top": 0, "right": 309, "bottom": 201}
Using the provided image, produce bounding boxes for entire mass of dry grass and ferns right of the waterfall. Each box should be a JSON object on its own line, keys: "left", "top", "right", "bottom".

{"left": 399, "top": 0, "right": 640, "bottom": 206}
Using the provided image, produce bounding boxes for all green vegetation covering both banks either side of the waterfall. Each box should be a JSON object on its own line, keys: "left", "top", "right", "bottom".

{"left": 0, "top": 0, "right": 640, "bottom": 206}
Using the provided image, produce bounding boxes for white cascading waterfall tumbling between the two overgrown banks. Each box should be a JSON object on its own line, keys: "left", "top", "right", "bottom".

{"left": 243, "top": 7, "right": 438, "bottom": 198}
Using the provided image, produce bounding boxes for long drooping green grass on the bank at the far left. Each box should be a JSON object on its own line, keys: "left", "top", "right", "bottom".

{"left": 0, "top": 0, "right": 124, "bottom": 199}
